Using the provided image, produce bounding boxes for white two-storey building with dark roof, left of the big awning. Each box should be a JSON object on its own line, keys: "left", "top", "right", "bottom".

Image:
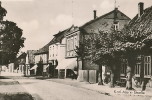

{"left": 49, "top": 29, "right": 67, "bottom": 78}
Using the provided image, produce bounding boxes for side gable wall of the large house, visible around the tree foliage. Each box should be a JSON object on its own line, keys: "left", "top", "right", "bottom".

{"left": 81, "top": 13, "right": 130, "bottom": 70}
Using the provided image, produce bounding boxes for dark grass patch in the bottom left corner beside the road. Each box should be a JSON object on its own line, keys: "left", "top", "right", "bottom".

{"left": 0, "top": 93, "right": 34, "bottom": 100}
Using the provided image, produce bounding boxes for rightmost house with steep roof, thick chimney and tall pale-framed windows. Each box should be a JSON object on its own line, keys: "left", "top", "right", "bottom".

{"left": 121, "top": 2, "right": 152, "bottom": 87}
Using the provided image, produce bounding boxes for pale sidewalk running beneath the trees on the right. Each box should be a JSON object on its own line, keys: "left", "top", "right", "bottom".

{"left": 47, "top": 79, "right": 152, "bottom": 97}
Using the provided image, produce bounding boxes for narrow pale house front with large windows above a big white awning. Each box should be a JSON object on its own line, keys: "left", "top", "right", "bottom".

{"left": 53, "top": 25, "right": 79, "bottom": 78}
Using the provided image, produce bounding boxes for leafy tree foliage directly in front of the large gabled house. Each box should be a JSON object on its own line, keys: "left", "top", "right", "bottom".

{"left": 86, "top": 31, "right": 122, "bottom": 66}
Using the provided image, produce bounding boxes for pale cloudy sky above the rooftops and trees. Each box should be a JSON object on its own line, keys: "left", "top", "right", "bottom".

{"left": 0, "top": 0, "right": 152, "bottom": 52}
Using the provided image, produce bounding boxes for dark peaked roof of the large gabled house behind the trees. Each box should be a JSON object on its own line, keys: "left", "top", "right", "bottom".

{"left": 81, "top": 8, "right": 130, "bottom": 28}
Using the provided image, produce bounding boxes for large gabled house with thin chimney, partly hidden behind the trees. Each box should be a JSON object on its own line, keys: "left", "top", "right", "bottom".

{"left": 66, "top": 8, "right": 130, "bottom": 80}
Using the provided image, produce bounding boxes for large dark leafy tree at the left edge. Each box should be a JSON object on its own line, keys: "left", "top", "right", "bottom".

{"left": 0, "top": 1, "right": 25, "bottom": 64}
